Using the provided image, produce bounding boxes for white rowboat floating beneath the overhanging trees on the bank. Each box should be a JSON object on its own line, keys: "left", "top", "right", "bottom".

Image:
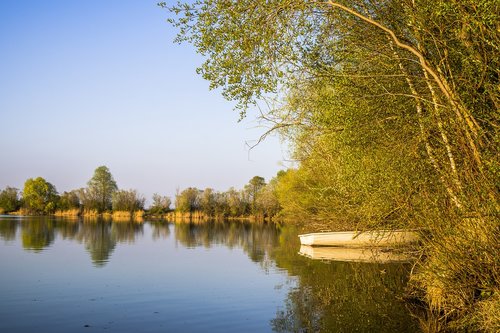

{"left": 299, "top": 230, "right": 419, "bottom": 247}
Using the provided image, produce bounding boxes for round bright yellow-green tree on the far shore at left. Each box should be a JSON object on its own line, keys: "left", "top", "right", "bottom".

{"left": 23, "top": 177, "right": 58, "bottom": 214}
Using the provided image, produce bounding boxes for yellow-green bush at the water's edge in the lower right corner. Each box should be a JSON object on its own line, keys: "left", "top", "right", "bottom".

{"left": 412, "top": 218, "right": 500, "bottom": 332}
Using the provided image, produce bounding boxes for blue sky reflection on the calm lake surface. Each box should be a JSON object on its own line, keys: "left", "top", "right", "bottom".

{"left": 0, "top": 221, "right": 294, "bottom": 332}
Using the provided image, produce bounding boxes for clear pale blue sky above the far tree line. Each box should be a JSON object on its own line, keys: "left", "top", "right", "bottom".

{"left": 0, "top": 0, "right": 286, "bottom": 200}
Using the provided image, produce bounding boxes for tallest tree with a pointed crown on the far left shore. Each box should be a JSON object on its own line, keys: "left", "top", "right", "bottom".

{"left": 87, "top": 166, "right": 118, "bottom": 212}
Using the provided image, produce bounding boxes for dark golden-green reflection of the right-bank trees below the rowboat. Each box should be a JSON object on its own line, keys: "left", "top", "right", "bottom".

{"left": 271, "top": 224, "right": 419, "bottom": 332}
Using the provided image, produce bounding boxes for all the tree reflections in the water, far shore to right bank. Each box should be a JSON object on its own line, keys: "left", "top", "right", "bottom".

{"left": 8, "top": 218, "right": 418, "bottom": 333}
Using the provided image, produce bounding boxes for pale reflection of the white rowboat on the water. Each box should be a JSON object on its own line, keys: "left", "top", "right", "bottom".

{"left": 299, "top": 245, "right": 412, "bottom": 264}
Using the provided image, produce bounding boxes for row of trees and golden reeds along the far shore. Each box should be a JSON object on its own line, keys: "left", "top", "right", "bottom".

{"left": 0, "top": 166, "right": 284, "bottom": 222}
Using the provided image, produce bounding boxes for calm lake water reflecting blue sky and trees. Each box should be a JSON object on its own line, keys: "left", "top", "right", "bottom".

{"left": 0, "top": 216, "right": 420, "bottom": 333}
